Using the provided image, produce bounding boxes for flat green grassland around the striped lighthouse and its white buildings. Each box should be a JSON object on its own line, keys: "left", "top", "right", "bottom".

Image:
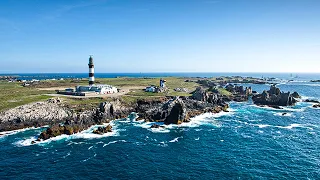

{"left": 0, "top": 77, "right": 197, "bottom": 112}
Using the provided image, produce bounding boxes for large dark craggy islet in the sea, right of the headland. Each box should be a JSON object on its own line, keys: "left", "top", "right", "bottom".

{"left": 252, "top": 85, "right": 299, "bottom": 106}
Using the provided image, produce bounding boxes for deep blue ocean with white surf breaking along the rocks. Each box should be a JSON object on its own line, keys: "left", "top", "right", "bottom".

{"left": 0, "top": 73, "right": 320, "bottom": 179}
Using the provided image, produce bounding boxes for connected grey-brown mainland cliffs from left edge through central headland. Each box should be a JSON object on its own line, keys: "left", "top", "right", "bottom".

{"left": 0, "top": 92, "right": 232, "bottom": 141}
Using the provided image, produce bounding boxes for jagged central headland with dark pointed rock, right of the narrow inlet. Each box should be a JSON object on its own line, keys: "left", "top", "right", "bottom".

{"left": 136, "top": 91, "right": 228, "bottom": 124}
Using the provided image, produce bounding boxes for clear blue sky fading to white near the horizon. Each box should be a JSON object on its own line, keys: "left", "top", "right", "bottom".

{"left": 0, "top": 0, "right": 320, "bottom": 73}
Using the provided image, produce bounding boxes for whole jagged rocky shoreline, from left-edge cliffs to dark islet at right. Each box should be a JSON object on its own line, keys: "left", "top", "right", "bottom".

{"left": 0, "top": 84, "right": 308, "bottom": 143}
